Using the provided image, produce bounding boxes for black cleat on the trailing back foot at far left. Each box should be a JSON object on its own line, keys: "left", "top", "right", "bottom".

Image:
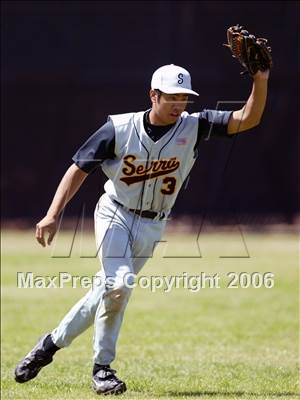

{"left": 15, "top": 333, "right": 54, "bottom": 383}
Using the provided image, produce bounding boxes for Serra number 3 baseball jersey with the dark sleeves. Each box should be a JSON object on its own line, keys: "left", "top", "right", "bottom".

{"left": 73, "top": 110, "right": 231, "bottom": 214}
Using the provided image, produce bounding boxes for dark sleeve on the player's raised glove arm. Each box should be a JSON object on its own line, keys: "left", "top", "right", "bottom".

{"left": 193, "top": 110, "right": 234, "bottom": 147}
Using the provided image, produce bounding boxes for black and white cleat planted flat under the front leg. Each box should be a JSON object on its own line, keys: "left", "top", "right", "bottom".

{"left": 93, "top": 365, "right": 127, "bottom": 395}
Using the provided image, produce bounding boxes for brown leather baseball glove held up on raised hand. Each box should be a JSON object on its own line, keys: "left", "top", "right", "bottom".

{"left": 224, "top": 25, "right": 272, "bottom": 75}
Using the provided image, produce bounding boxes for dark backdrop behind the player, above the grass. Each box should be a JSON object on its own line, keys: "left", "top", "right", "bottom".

{"left": 1, "top": 1, "right": 300, "bottom": 223}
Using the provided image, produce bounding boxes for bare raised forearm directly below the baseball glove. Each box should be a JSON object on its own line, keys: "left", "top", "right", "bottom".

{"left": 227, "top": 71, "right": 269, "bottom": 134}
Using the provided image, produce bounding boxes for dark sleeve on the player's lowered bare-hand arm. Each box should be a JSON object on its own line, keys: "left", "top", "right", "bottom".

{"left": 72, "top": 121, "right": 115, "bottom": 173}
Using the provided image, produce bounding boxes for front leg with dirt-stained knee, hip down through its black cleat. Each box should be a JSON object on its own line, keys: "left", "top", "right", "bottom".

{"left": 93, "top": 210, "right": 165, "bottom": 394}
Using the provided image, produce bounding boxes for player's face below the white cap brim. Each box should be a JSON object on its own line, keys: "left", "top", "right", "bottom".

{"left": 150, "top": 92, "right": 188, "bottom": 125}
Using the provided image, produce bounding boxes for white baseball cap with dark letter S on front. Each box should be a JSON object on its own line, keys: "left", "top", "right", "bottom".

{"left": 151, "top": 64, "right": 199, "bottom": 96}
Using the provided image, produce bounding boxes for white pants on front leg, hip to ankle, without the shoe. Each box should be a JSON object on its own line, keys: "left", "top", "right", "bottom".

{"left": 94, "top": 199, "right": 165, "bottom": 365}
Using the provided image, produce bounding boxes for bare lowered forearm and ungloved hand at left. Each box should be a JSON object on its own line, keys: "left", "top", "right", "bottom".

{"left": 35, "top": 164, "right": 88, "bottom": 247}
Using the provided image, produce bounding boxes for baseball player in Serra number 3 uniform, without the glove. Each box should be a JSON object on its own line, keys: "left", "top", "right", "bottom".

{"left": 15, "top": 64, "right": 269, "bottom": 394}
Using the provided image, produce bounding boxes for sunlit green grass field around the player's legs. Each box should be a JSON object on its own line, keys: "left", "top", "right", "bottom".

{"left": 1, "top": 231, "right": 299, "bottom": 400}
